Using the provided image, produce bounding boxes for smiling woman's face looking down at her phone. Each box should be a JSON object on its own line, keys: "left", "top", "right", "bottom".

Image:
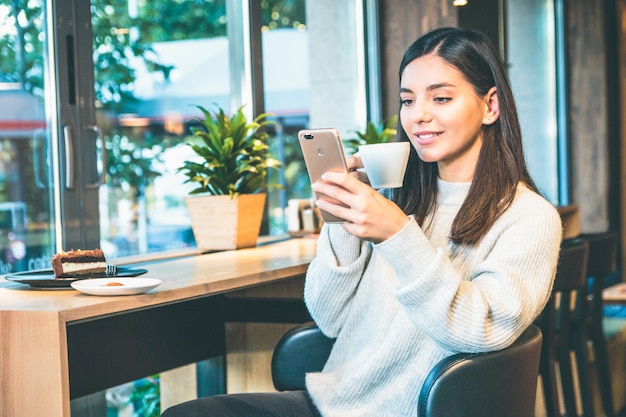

{"left": 400, "top": 54, "right": 498, "bottom": 182}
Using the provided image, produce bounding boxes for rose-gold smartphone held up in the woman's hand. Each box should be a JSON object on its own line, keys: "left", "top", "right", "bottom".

{"left": 298, "top": 128, "right": 348, "bottom": 223}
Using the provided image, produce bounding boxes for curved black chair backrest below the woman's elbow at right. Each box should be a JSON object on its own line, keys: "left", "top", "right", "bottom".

{"left": 417, "top": 325, "right": 542, "bottom": 417}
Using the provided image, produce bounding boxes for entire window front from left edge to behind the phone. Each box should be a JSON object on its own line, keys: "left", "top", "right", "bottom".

{"left": 0, "top": 0, "right": 370, "bottom": 266}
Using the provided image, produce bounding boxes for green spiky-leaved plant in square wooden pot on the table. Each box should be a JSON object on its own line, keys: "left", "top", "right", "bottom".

{"left": 178, "top": 106, "right": 280, "bottom": 250}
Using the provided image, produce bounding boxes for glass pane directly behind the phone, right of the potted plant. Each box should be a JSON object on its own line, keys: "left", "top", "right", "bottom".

{"left": 262, "top": 0, "right": 366, "bottom": 234}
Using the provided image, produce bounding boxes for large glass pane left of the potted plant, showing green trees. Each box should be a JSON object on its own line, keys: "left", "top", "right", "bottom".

{"left": 92, "top": 0, "right": 230, "bottom": 258}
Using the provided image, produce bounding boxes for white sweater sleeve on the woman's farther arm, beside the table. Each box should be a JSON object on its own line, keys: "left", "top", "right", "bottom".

{"left": 304, "top": 223, "right": 372, "bottom": 337}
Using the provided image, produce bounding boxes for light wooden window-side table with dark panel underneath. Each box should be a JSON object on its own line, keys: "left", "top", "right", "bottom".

{"left": 0, "top": 239, "right": 316, "bottom": 417}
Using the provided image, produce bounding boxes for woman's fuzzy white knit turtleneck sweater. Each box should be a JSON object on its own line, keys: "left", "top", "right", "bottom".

{"left": 305, "top": 181, "right": 562, "bottom": 417}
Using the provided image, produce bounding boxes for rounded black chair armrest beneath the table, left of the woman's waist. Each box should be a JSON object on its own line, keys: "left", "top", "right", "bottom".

{"left": 272, "top": 322, "right": 335, "bottom": 391}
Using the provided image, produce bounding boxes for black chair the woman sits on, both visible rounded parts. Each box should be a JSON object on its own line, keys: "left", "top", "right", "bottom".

{"left": 272, "top": 323, "right": 542, "bottom": 417}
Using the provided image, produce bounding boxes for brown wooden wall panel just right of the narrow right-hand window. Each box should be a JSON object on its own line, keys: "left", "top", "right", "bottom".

{"left": 566, "top": 0, "right": 610, "bottom": 232}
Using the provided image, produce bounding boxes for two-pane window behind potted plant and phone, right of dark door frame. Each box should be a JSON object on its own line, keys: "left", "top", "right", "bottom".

{"left": 92, "top": 0, "right": 365, "bottom": 258}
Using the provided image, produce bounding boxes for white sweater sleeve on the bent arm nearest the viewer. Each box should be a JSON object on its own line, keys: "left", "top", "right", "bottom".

{"left": 375, "top": 195, "right": 562, "bottom": 352}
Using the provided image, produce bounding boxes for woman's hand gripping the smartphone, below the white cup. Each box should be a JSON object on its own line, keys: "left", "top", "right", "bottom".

{"left": 312, "top": 172, "right": 409, "bottom": 243}
